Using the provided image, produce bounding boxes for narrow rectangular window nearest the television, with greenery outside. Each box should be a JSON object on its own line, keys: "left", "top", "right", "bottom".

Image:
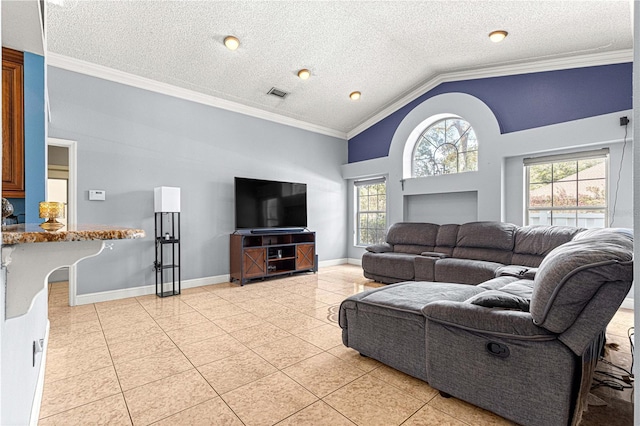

{"left": 355, "top": 178, "right": 387, "bottom": 246}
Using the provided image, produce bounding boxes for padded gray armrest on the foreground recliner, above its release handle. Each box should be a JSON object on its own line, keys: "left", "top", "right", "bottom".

{"left": 422, "top": 300, "right": 557, "bottom": 340}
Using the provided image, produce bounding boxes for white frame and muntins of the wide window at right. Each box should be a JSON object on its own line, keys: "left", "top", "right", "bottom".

{"left": 523, "top": 148, "right": 611, "bottom": 228}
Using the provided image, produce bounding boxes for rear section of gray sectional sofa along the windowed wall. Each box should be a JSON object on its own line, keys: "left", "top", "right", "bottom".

{"left": 362, "top": 222, "right": 582, "bottom": 284}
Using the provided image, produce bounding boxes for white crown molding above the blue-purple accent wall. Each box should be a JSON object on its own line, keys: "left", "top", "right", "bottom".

{"left": 347, "top": 49, "right": 633, "bottom": 139}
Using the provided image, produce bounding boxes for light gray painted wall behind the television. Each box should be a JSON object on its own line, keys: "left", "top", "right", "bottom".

{"left": 48, "top": 67, "right": 347, "bottom": 294}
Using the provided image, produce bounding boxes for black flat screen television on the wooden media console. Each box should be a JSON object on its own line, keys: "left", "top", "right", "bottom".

{"left": 235, "top": 177, "right": 307, "bottom": 230}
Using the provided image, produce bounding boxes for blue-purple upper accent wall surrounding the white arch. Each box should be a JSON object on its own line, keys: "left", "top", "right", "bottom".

{"left": 349, "top": 63, "right": 633, "bottom": 163}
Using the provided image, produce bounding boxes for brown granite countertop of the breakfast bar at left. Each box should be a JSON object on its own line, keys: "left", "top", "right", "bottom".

{"left": 2, "top": 223, "right": 145, "bottom": 244}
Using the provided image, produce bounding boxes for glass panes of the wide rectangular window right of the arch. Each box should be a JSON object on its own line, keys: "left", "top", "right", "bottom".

{"left": 525, "top": 150, "right": 608, "bottom": 228}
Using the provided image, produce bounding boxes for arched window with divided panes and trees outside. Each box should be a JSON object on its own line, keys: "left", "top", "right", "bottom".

{"left": 411, "top": 117, "right": 478, "bottom": 177}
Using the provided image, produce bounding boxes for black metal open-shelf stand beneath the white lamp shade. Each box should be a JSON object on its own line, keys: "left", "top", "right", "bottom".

{"left": 153, "top": 212, "right": 180, "bottom": 297}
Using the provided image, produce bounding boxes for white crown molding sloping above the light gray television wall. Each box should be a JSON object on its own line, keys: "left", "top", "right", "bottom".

{"left": 45, "top": 52, "right": 347, "bottom": 140}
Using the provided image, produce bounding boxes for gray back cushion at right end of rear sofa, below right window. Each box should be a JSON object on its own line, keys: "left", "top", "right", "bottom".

{"left": 511, "top": 226, "right": 582, "bottom": 267}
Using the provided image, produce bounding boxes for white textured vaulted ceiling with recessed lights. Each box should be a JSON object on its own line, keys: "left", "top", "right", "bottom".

{"left": 47, "top": 0, "right": 633, "bottom": 133}
